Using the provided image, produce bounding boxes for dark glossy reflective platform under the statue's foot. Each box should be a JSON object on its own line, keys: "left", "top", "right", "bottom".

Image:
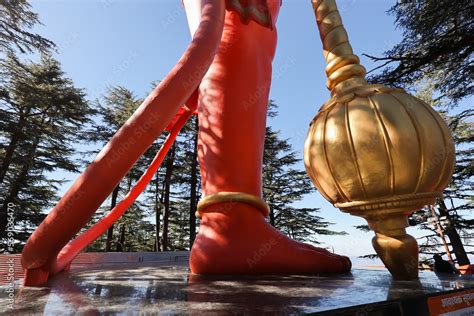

{"left": 0, "top": 252, "right": 474, "bottom": 316}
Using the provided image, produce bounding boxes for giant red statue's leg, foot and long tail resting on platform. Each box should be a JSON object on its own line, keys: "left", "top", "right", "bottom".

{"left": 22, "top": 0, "right": 351, "bottom": 285}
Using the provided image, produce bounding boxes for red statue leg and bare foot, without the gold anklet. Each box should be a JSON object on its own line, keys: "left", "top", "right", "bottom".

{"left": 185, "top": 0, "right": 351, "bottom": 274}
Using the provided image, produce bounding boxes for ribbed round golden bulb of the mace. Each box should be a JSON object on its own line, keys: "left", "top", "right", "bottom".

{"left": 305, "top": 86, "right": 454, "bottom": 208}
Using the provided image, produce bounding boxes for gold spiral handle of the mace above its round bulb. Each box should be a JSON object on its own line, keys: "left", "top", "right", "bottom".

{"left": 311, "top": 0, "right": 367, "bottom": 95}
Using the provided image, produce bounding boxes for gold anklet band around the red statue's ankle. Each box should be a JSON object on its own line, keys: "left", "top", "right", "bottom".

{"left": 196, "top": 192, "right": 270, "bottom": 217}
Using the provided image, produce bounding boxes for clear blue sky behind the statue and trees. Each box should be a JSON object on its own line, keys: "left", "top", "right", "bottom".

{"left": 29, "top": 0, "right": 466, "bottom": 256}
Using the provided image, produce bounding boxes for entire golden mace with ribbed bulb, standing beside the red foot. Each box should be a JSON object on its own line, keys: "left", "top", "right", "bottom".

{"left": 304, "top": 0, "right": 454, "bottom": 279}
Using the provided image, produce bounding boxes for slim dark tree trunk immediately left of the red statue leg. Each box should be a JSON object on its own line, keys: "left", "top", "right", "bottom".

{"left": 189, "top": 117, "right": 199, "bottom": 249}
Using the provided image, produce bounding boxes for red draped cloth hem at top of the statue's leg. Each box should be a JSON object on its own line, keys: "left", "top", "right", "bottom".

{"left": 226, "top": 0, "right": 281, "bottom": 29}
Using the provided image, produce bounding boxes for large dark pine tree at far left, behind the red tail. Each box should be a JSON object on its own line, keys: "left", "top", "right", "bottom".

{"left": 0, "top": 55, "right": 93, "bottom": 250}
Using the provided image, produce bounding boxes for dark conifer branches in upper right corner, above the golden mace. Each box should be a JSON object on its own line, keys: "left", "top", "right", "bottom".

{"left": 369, "top": 0, "right": 474, "bottom": 103}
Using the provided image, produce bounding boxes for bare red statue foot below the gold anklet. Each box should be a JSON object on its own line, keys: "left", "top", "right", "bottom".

{"left": 190, "top": 202, "right": 351, "bottom": 274}
